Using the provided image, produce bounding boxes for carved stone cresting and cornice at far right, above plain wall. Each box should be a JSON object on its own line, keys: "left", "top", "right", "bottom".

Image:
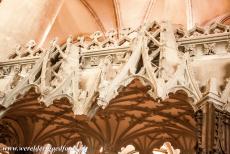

{"left": 174, "top": 23, "right": 229, "bottom": 56}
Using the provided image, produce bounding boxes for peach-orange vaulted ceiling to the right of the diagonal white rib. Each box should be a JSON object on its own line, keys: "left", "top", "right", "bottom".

{"left": 45, "top": 0, "right": 230, "bottom": 44}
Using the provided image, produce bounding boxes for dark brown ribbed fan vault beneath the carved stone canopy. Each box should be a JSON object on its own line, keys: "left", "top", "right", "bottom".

{"left": 1, "top": 80, "right": 196, "bottom": 154}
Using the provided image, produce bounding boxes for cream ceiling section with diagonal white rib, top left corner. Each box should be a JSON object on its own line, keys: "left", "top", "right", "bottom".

{"left": 0, "top": 0, "right": 64, "bottom": 60}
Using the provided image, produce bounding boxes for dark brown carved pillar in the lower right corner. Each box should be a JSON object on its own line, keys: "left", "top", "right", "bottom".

{"left": 195, "top": 99, "right": 230, "bottom": 153}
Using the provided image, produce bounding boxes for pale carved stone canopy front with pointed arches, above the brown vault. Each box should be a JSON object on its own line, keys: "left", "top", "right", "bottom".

{"left": 0, "top": 22, "right": 228, "bottom": 114}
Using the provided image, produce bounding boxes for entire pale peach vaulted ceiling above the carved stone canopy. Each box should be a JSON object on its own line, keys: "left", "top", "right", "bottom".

{"left": 0, "top": 0, "right": 230, "bottom": 59}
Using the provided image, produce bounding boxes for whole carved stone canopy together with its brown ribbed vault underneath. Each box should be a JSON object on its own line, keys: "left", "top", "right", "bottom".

{"left": 0, "top": 22, "right": 230, "bottom": 154}
